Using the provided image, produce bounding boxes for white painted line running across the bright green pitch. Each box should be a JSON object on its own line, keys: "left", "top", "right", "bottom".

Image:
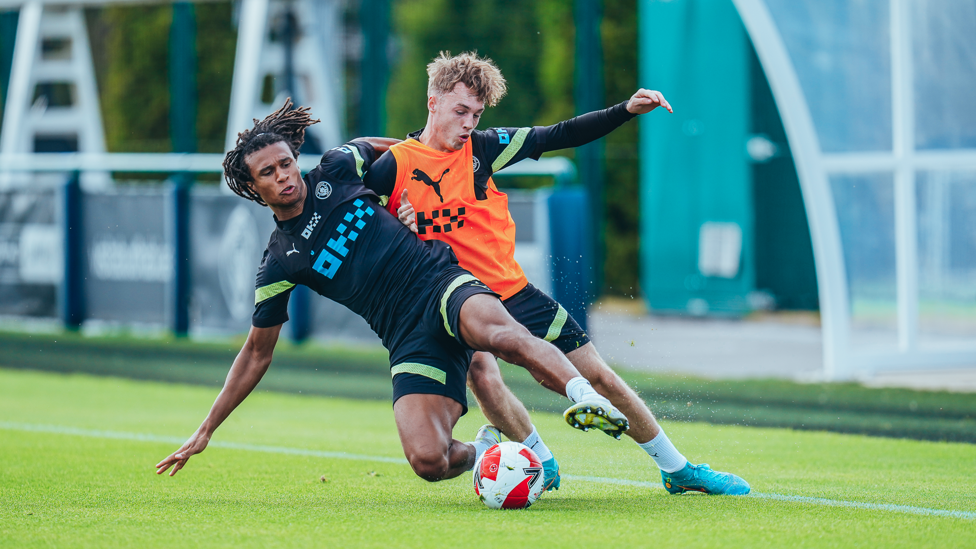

{"left": 0, "top": 421, "right": 976, "bottom": 520}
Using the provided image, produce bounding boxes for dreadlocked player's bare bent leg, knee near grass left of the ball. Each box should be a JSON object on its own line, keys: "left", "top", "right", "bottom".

{"left": 393, "top": 394, "right": 475, "bottom": 482}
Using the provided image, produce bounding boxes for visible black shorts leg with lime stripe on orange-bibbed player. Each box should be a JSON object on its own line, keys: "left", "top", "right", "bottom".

{"left": 502, "top": 284, "right": 590, "bottom": 354}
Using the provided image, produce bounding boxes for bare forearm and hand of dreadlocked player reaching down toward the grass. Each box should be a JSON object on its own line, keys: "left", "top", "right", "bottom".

{"left": 156, "top": 324, "right": 281, "bottom": 476}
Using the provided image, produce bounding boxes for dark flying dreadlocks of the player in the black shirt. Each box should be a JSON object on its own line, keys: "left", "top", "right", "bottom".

{"left": 224, "top": 97, "right": 321, "bottom": 206}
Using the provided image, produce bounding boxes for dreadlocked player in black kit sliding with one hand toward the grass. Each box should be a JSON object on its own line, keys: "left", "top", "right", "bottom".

{"left": 156, "top": 100, "right": 627, "bottom": 481}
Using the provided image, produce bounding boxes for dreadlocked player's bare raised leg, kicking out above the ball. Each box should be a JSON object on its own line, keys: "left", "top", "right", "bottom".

{"left": 459, "top": 294, "right": 580, "bottom": 396}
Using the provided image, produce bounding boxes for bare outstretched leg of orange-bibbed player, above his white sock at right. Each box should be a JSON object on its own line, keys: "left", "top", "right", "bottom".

{"left": 566, "top": 343, "right": 661, "bottom": 444}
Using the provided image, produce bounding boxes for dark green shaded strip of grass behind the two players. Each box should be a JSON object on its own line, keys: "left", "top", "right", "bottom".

{"left": 0, "top": 332, "right": 976, "bottom": 443}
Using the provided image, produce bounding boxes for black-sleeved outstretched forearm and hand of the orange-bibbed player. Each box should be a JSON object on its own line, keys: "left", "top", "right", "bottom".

{"left": 539, "top": 88, "right": 674, "bottom": 153}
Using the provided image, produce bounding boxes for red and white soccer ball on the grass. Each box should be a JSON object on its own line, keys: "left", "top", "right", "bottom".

{"left": 474, "top": 441, "right": 545, "bottom": 509}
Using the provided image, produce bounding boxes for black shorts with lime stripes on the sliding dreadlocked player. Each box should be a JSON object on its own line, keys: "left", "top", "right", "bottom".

{"left": 390, "top": 265, "right": 498, "bottom": 415}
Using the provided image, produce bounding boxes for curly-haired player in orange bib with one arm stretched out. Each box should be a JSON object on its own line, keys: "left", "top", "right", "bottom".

{"left": 365, "top": 52, "right": 749, "bottom": 494}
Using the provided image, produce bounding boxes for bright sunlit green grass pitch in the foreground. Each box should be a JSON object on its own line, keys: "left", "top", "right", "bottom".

{"left": 0, "top": 370, "right": 976, "bottom": 549}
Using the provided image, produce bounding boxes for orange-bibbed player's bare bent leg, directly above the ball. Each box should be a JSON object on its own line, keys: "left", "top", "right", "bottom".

{"left": 468, "top": 353, "right": 532, "bottom": 442}
